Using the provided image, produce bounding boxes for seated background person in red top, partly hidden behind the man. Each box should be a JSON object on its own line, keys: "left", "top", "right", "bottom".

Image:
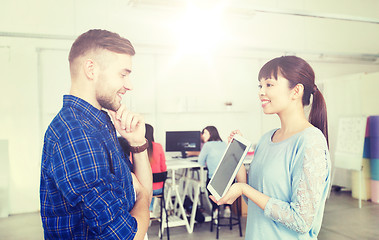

{"left": 145, "top": 123, "right": 167, "bottom": 215}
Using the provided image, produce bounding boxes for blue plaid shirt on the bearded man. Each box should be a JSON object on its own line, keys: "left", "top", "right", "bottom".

{"left": 40, "top": 95, "right": 137, "bottom": 239}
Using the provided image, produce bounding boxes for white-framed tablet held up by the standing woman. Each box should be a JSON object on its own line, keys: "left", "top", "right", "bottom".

{"left": 207, "top": 135, "right": 251, "bottom": 201}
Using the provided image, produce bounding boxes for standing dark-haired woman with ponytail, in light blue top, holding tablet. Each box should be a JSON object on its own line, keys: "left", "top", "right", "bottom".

{"left": 211, "top": 56, "right": 331, "bottom": 240}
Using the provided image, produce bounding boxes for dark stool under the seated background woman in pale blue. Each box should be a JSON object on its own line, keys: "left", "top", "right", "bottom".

{"left": 211, "top": 198, "right": 243, "bottom": 239}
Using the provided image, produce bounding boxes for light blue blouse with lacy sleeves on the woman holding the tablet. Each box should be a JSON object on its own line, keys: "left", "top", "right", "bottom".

{"left": 246, "top": 127, "right": 331, "bottom": 240}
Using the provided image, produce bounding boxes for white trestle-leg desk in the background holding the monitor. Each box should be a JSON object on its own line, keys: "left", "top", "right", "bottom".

{"left": 162, "top": 158, "right": 204, "bottom": 233}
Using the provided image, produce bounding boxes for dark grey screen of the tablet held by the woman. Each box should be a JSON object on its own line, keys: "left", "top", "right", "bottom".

{"left": 209, "top": 139, "right": 247, "bottom": 196}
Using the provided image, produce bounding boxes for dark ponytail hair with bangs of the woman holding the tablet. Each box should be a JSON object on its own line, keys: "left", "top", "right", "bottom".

{"left": 258, "top": 56, "right": 329, "bottom": 144}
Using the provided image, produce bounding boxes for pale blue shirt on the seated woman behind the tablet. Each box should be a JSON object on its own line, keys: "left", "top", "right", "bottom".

{"left": 198, "top": 141, "right": 227, "bottom": 179}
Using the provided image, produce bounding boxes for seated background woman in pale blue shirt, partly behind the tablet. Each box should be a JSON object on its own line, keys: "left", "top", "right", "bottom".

{"left": 199, "top": 126, "right": 230, "bottom": 218}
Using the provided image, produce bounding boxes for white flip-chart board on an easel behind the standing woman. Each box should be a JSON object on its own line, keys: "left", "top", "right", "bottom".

{"left": 334, "top": 117, "right": 367, "bottom": 171}
